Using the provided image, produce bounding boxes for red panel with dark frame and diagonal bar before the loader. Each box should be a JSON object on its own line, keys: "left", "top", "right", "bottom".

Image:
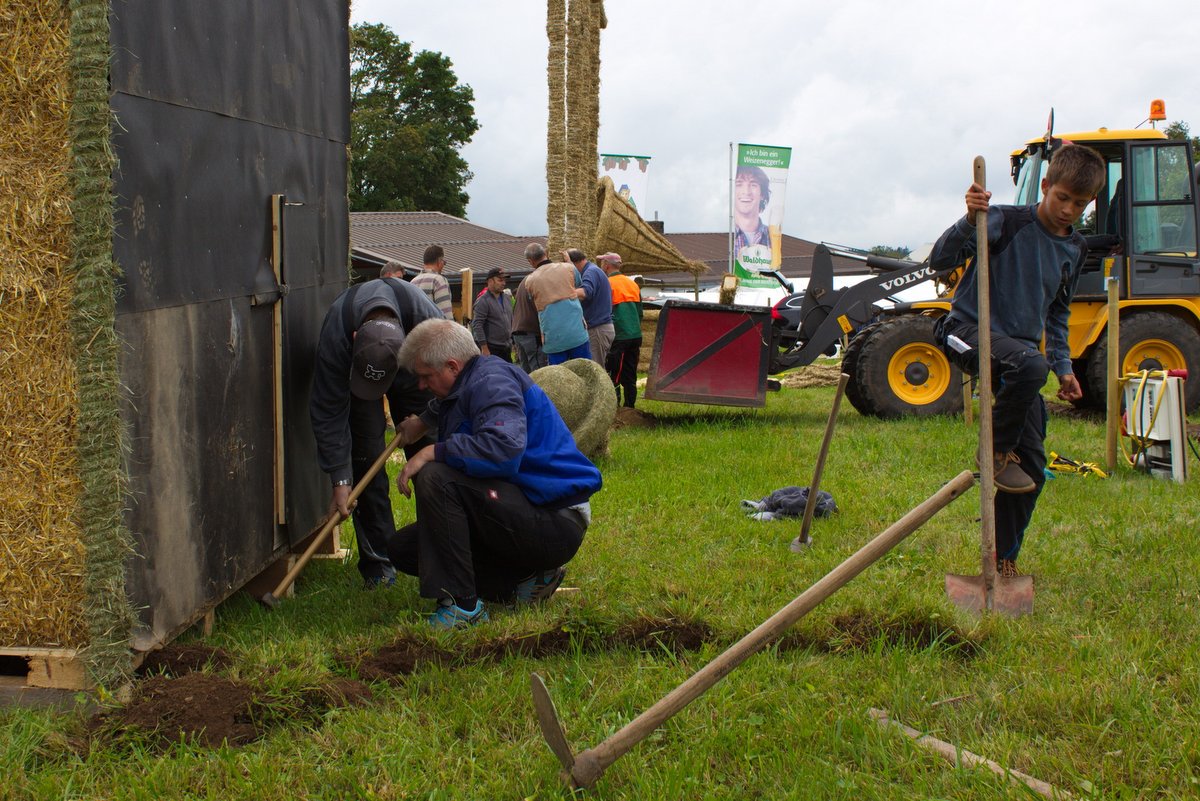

{"left": 646, "top": 301, "right": 770, "bottom": 406}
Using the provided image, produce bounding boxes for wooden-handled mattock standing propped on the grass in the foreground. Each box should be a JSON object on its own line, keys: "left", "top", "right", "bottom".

{"left": 530, "top": 471, "right": 974, "bottom": 788}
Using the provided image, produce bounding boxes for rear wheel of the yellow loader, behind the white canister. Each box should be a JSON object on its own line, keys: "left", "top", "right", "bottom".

{"left": 1087, "top": 312, "right": 1200, "bottom": 414}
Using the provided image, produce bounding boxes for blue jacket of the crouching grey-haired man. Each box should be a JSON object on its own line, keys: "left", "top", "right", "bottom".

{"left": 421, "top": 356, "right": 601, "bottom": 508}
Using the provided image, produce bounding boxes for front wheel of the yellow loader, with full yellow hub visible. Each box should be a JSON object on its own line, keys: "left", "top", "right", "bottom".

{"left": 852, "top": 314, "right": 962, "bottom": 418}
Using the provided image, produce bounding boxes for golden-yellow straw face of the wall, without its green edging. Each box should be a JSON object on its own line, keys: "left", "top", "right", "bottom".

{"left": 0, "top": 0, "right": 86, "bottom": 646}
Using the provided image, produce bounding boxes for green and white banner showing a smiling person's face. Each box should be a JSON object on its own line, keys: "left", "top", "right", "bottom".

{"left": 730, "top": 144, "right": 792, "bottom": 287}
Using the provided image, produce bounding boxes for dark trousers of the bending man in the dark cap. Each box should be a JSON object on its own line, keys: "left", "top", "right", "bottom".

{"left": 350, "top": 369, "right": 433, "bottom": 578}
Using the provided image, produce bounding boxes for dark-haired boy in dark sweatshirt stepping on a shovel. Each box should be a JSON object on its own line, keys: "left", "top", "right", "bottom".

{"left": 930, "top": 144, "right": 1105, "bottom": 577}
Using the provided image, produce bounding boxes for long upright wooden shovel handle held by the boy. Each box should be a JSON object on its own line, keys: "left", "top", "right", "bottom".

{"left": 973, "top": 156, "right": 996, "bottom": 594}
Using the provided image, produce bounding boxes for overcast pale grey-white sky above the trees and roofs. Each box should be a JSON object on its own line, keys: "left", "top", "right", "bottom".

{"left": 352, "top": 0, "right": 1200, "bottom": 248}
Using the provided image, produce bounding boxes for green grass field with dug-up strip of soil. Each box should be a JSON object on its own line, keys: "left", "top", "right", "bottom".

{"left": 0, "top": 376, "right": 1200, "bottom": 801}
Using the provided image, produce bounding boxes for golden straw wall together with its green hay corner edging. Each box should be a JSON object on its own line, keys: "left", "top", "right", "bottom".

{"left": 0, "top": 0, "right": 132, "bottom": 685}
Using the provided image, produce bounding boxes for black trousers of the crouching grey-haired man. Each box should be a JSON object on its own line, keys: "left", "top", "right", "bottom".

{"left": 388, "top": 462, "right": 586, "bottom": 602}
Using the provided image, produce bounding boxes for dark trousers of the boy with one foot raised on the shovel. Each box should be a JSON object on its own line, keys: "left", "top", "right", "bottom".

{"left": 936, "top": 317, "right": 1050, "bottom": 561}
